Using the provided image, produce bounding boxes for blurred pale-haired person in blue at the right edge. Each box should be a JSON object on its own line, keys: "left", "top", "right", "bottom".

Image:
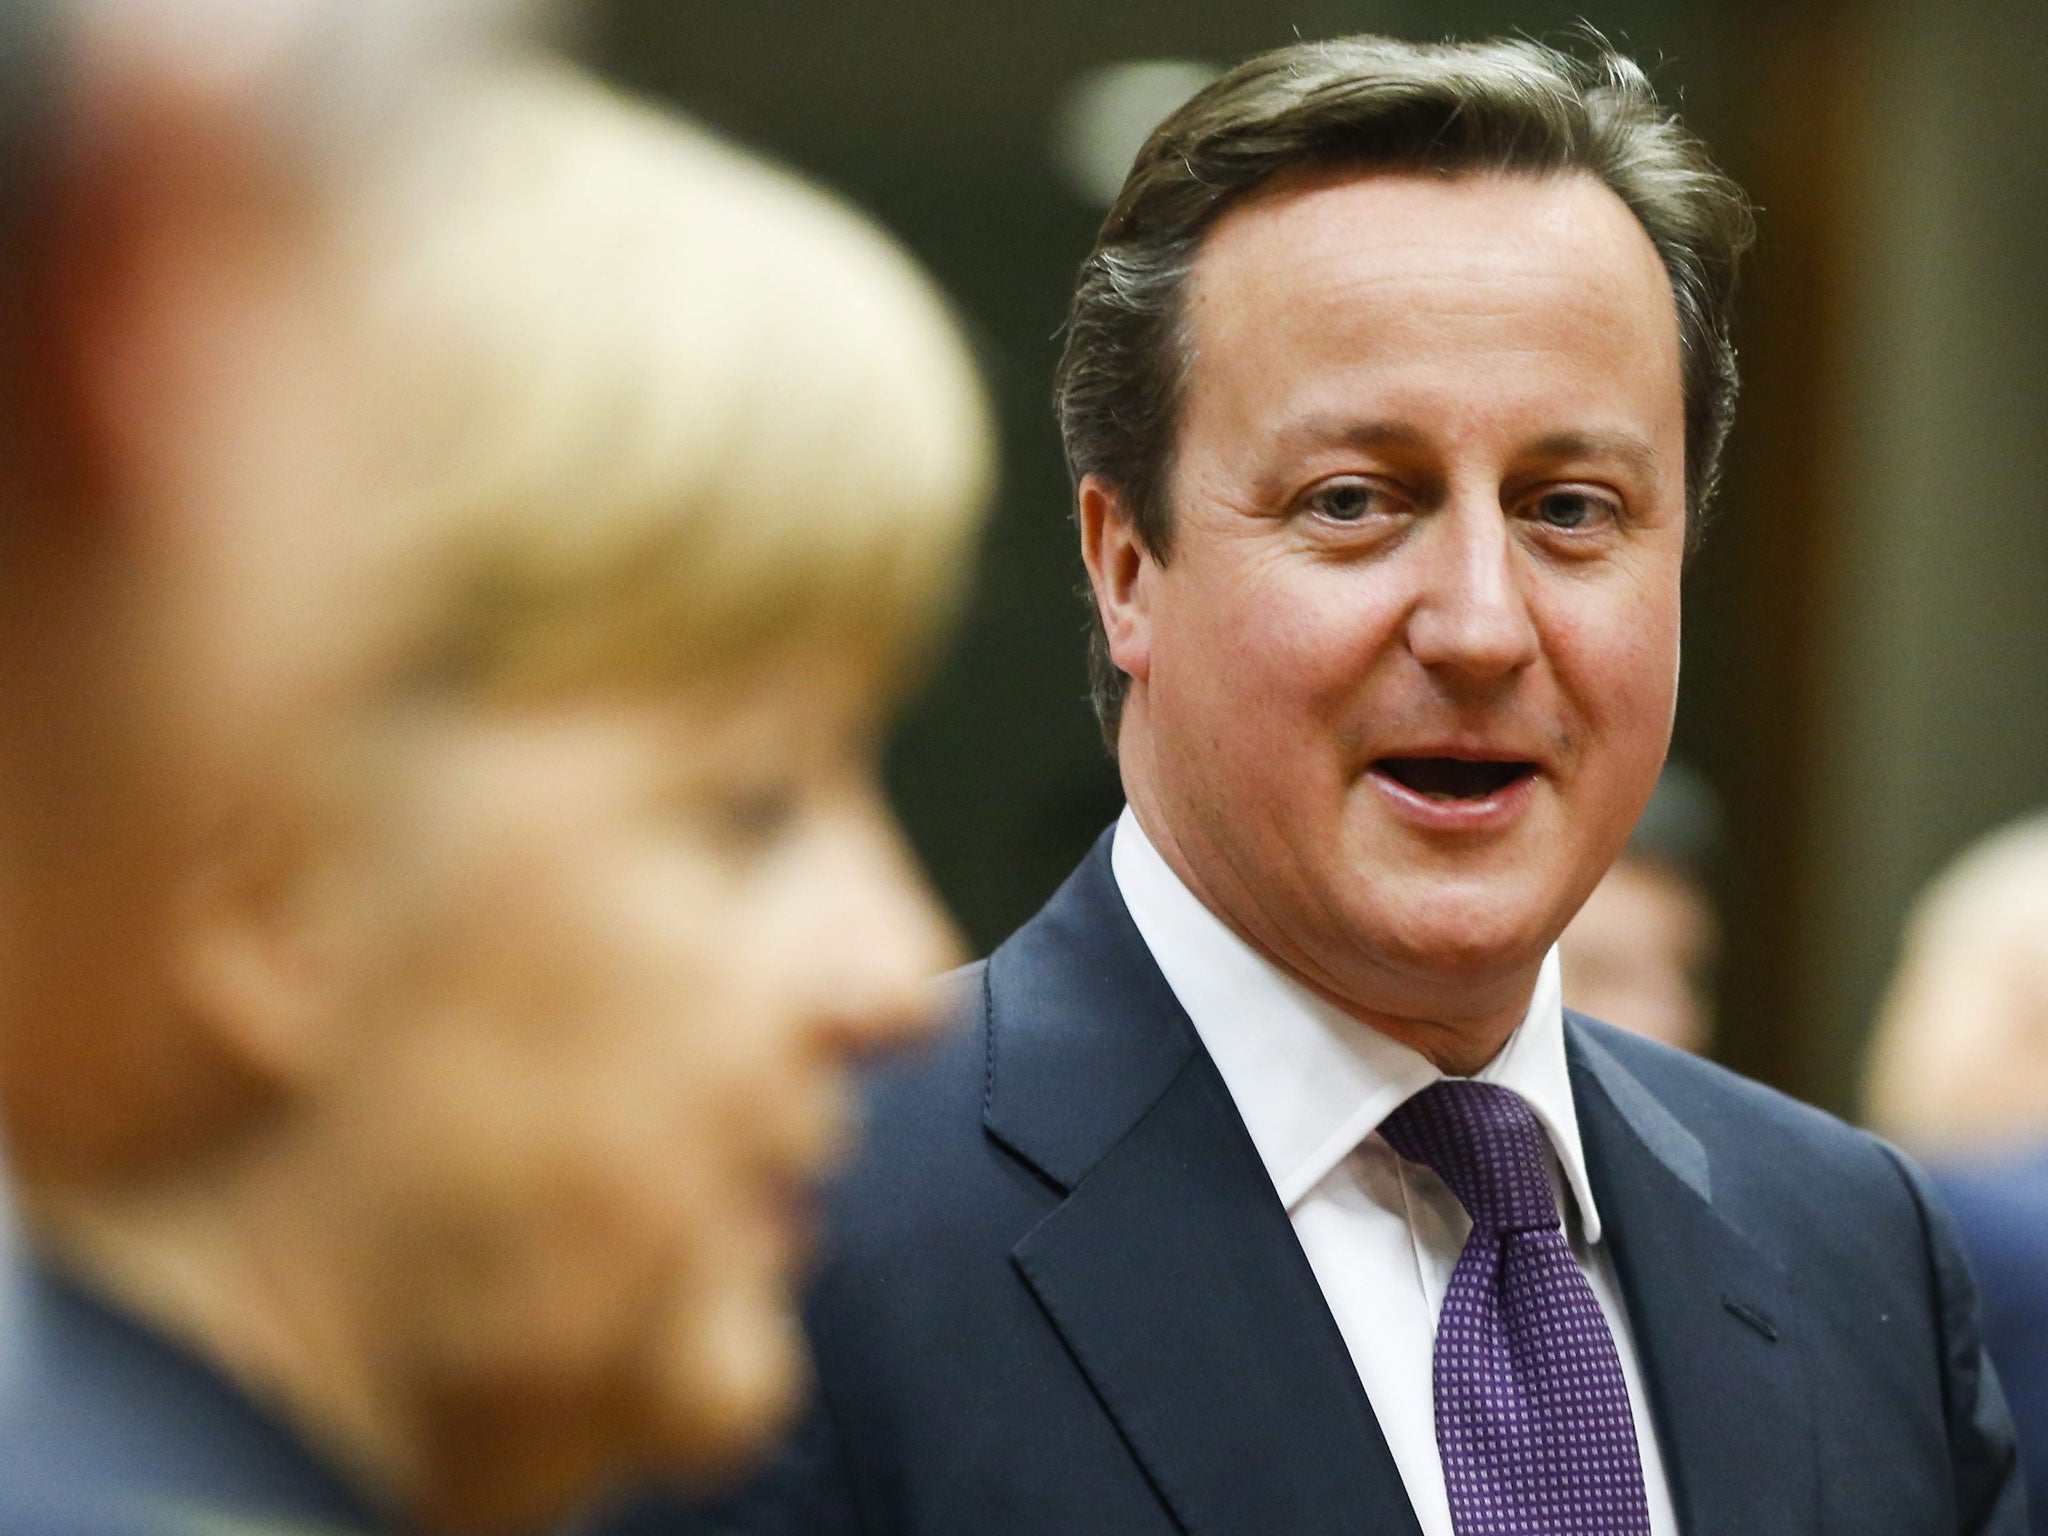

{"left": 1864, "top": 815, "right": 2048, "bottom": 1536}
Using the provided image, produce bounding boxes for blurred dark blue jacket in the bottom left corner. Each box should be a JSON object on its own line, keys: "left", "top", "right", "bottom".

{"left": 0, "top": 1251, "right": 397, "bottom": 1536}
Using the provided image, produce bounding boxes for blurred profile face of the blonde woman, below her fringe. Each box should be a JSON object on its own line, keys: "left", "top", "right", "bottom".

{"left": 328, "top": 657, "right": 956, "bottom": 1503}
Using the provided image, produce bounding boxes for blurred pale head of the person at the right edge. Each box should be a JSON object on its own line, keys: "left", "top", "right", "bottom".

{"left": 1866, "top": 815, "right": 2048, "bottom": 1155}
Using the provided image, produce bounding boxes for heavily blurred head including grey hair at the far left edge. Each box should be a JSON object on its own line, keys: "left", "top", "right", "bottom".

{"left": 0, "top": 0, "right": 585, "bottom": 1236}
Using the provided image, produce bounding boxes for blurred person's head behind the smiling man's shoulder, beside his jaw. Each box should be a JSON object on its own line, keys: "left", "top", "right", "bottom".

{"left": 1556, "top": 760, "right": 1720, "bottom": 1055}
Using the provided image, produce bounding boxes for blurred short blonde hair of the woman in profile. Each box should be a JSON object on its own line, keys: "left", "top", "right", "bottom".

{"left": 350, "top": 66, "right": 993, "bottom": 694}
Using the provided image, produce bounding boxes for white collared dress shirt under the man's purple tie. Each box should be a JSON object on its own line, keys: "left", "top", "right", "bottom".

{"left": 1110, "top": 809, "right": 1677, "bottom": 1536}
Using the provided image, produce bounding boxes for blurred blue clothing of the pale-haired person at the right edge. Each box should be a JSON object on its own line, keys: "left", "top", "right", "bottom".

{"left": 1935, "top": 1147, "right": 2048, "bottom": 1536}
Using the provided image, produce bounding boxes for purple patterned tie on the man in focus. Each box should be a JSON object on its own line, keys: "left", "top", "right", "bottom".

{"left": 1380, "top": 1079, "right": 1651, "bottom": 1536}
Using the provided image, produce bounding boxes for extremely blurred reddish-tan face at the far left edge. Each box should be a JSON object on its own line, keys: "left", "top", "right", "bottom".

{"left": 0, "top": 83, "right": 419, "bottom": 1176}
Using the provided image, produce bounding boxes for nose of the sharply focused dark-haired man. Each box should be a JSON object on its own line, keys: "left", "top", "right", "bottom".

{"left": 1409, "top": 496, "right": 1540, "bottom": 684}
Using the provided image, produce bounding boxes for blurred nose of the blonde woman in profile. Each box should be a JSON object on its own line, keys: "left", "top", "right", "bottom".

{"left": 821, "top": 811, "right": 967, "bottom": 1055}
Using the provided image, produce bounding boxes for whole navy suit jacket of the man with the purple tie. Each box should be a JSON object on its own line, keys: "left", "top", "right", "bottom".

{"left": 623, "top": 840, "right": 2025, "bottom": 1536}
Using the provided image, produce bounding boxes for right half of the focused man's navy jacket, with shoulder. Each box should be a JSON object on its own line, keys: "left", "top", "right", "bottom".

{"left": 1567, "top": 1016, "right": 2025, "bottom": 1532}
